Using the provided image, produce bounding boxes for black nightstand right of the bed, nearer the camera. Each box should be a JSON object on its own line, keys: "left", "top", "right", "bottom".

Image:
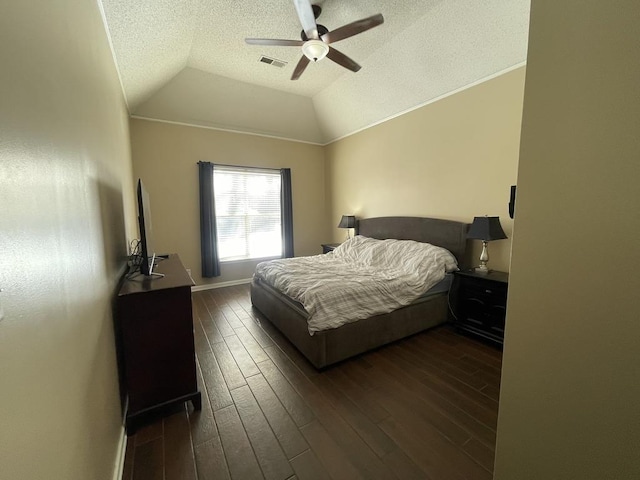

{"left": 452, "top": 270, "right": 509, "bottom": 345}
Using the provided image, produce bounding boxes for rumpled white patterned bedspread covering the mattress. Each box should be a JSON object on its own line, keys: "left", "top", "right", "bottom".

{"left": 255, "top": 236, "right": 458, "bottom": 335}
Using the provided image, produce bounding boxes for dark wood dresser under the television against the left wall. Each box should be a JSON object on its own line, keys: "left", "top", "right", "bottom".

{"left": 116, "top": 254, "right": 201, "bottom": 434}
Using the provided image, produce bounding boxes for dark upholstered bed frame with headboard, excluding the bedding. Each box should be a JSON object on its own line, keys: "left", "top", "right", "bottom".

{"left": 251, "top": 217, "right": 468, "bottom": 369}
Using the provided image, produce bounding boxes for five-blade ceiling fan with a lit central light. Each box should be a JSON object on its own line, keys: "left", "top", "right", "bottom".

{"left": 245, "top": 0, "right": 384, "bottom": 80}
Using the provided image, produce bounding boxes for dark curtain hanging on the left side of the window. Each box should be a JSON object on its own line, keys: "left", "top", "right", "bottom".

{"left": 198, "top": 162, "right": 220, "bottom": 278}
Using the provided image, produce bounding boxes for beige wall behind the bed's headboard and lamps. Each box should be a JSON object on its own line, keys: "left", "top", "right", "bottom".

{"left": 326, "top": 68, "right": 525, "bottom": 271}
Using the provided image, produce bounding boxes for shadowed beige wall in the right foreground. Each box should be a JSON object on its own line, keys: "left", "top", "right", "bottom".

{"left": 495, "top": 0, "right": 640, "bottom": 480}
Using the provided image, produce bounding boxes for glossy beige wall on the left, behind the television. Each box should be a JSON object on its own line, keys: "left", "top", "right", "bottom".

{"left": 0, "top": 0, "right": 135, "bottom": 480}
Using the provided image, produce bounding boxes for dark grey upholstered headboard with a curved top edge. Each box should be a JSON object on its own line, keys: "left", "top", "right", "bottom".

{"left": 356, "top": 217, "right": 469, "bottom": 265}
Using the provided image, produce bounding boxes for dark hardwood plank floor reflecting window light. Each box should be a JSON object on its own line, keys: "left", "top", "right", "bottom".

{"left": 123, "top": 285, "right": 502, "bottom": 480}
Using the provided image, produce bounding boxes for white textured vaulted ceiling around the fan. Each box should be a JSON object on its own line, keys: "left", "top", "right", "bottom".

{"left": 101, "top": 0, "right": 529, "bottom": 144}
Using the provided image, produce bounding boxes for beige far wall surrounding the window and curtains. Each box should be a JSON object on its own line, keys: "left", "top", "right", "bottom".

{"left": 131, "top": 119, "right": 329, "bottom": 285}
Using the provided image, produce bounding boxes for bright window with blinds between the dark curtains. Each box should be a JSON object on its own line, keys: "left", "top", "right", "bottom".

{"left": 213, "top": 165, "right": 282, "bottom": 261}
